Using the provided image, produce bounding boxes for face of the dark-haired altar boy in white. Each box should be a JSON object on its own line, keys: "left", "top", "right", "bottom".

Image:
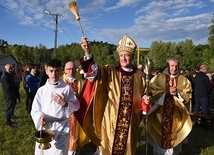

{"left": 46, "top": 66, "right": 62, "bottom": 83}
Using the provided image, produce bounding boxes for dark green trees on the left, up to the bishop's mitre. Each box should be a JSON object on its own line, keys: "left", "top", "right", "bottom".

{"left": 0, "top": 41, "right": 117, "bottom": 67}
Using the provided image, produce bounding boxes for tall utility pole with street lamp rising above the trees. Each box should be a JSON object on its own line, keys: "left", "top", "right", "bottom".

{"left": 45, "top": 11, "right": 62, "bottom": 57}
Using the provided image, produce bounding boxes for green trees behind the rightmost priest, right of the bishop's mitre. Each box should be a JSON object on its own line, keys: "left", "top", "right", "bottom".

{"left": 148, "top": 39, "right": 214, "bottom": 72}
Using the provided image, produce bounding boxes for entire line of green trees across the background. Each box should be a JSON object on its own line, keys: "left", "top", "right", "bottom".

{"left": 0, "top": 39, "right": 214, "bottom": 72}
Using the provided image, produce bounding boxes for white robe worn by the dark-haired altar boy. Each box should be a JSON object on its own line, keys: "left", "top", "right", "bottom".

{"left": 31, "top": 79, "right": 80, "bottom": 155}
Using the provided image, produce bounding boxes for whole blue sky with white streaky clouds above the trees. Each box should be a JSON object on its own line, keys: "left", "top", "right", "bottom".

{"left": 0, "top": 0, "right": 214, "bottom": 48}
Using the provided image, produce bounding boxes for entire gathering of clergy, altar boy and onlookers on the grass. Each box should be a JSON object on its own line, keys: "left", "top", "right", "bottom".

{"left": 1, "top": 35, "right": 214, "bottom": 155}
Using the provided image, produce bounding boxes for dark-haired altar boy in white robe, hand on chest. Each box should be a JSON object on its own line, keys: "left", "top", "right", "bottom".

{"left": 31, "top": 59, "right": 79, "bottom": 155}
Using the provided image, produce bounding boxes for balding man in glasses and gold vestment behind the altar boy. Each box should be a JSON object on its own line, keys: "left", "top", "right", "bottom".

{"left": 63, "top": 61, "right": 89, "bottom": 155}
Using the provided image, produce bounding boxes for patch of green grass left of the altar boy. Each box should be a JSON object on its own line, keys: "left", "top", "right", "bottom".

{"left": 0, "top": 81, "right": 36, "bottom": 155}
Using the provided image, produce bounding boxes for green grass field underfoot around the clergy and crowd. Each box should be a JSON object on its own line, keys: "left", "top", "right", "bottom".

{"left": 0, "top": 81, "right": 214, "bottom": 155}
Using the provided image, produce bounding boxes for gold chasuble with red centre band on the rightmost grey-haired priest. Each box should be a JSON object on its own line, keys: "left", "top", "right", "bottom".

{"left": 148, "top": 70, "right": 192, "bottom": 149}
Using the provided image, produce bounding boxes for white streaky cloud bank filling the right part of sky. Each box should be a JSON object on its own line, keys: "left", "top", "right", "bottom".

{"left": 89, "top": 0, "right": 212, "bottom": 46}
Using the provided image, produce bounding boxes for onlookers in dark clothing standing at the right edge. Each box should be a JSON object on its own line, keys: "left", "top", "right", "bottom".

{"left": 182, "top": 64, "right": 214, "bottom": 125}
